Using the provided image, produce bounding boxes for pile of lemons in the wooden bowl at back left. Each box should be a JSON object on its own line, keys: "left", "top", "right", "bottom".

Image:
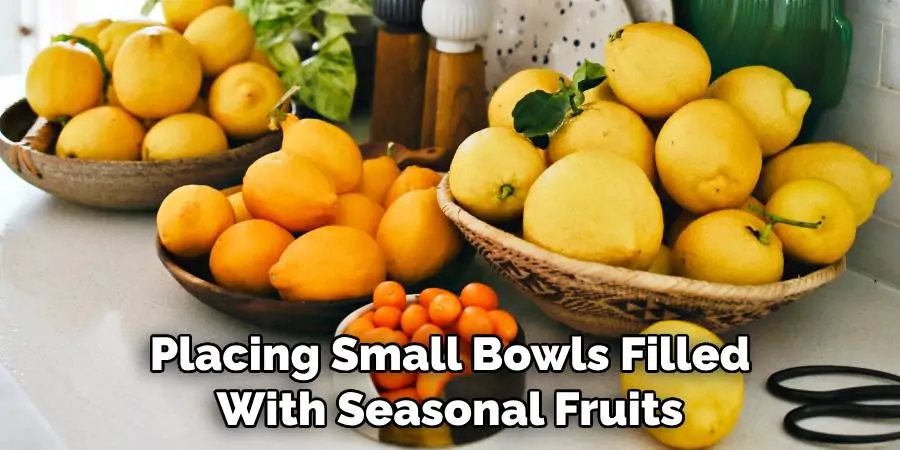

{"left": 26, "top": 0, "right": 285, "bottom": 161}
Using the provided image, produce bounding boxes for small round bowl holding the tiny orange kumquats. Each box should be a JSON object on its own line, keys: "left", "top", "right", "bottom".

{"left": 331, "top": 295, "right": 526, "bottom": 446}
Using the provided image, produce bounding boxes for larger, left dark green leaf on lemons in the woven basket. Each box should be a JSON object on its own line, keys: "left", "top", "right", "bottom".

{"left": 513, "top": 91, "right": 570, "bottom": 138}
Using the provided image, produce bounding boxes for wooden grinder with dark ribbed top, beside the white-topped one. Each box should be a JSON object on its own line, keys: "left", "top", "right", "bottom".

{"left": 369, "top": 0, "right": 430, "bottom": 148}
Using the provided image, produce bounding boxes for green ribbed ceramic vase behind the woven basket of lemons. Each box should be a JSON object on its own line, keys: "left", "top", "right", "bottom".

{"left": 673, "top": 0, "right": 852, "bottom": 139}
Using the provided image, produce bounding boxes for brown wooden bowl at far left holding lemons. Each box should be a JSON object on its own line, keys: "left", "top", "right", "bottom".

{"left": 0, "top": 99, "right": 281, "bottom": 211}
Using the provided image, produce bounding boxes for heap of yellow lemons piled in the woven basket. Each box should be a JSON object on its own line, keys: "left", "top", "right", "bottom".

{"left": 450, "top": 23, "right": 893, "bottom": 285}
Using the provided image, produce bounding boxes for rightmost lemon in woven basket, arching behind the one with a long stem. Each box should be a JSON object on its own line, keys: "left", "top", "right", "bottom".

{"left": 756, "top": 142, "right": 894, "bottom": 225}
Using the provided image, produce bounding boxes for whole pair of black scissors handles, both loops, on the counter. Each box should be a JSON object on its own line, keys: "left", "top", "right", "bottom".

{"left": 766, "top": 366, "right": 900, "bottom": 444}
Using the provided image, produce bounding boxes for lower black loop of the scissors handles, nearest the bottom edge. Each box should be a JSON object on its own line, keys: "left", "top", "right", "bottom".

{"left": 784, "top": 402, "right": 900, "bottom": 444}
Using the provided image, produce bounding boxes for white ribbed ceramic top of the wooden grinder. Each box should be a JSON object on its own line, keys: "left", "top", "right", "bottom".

{"left": 422, "top": 0, "right": 497, "bottom": 53}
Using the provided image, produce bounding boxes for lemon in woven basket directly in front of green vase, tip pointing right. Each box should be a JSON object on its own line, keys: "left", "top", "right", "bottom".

{"left": 708, "top": 66, "right": 812, "bottom": 158}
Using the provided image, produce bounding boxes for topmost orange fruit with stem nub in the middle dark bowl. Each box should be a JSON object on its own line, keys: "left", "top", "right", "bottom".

{"left": 284, "top": 117, "right": 363, "bottom": 194}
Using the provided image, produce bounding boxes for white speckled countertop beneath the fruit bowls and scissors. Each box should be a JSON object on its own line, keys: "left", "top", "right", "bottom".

{"left": 0, "top": 78, "right": 900, "bottom": 450}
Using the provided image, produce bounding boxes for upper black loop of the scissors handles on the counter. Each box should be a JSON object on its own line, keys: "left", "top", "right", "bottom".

{"left": 766, "top": 366, "right": 900, "bottom": 403}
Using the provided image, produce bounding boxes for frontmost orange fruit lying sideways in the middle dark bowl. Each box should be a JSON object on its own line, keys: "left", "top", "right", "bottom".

{"left": 269, "top": 225, "right": 386, "bottom": 301}
